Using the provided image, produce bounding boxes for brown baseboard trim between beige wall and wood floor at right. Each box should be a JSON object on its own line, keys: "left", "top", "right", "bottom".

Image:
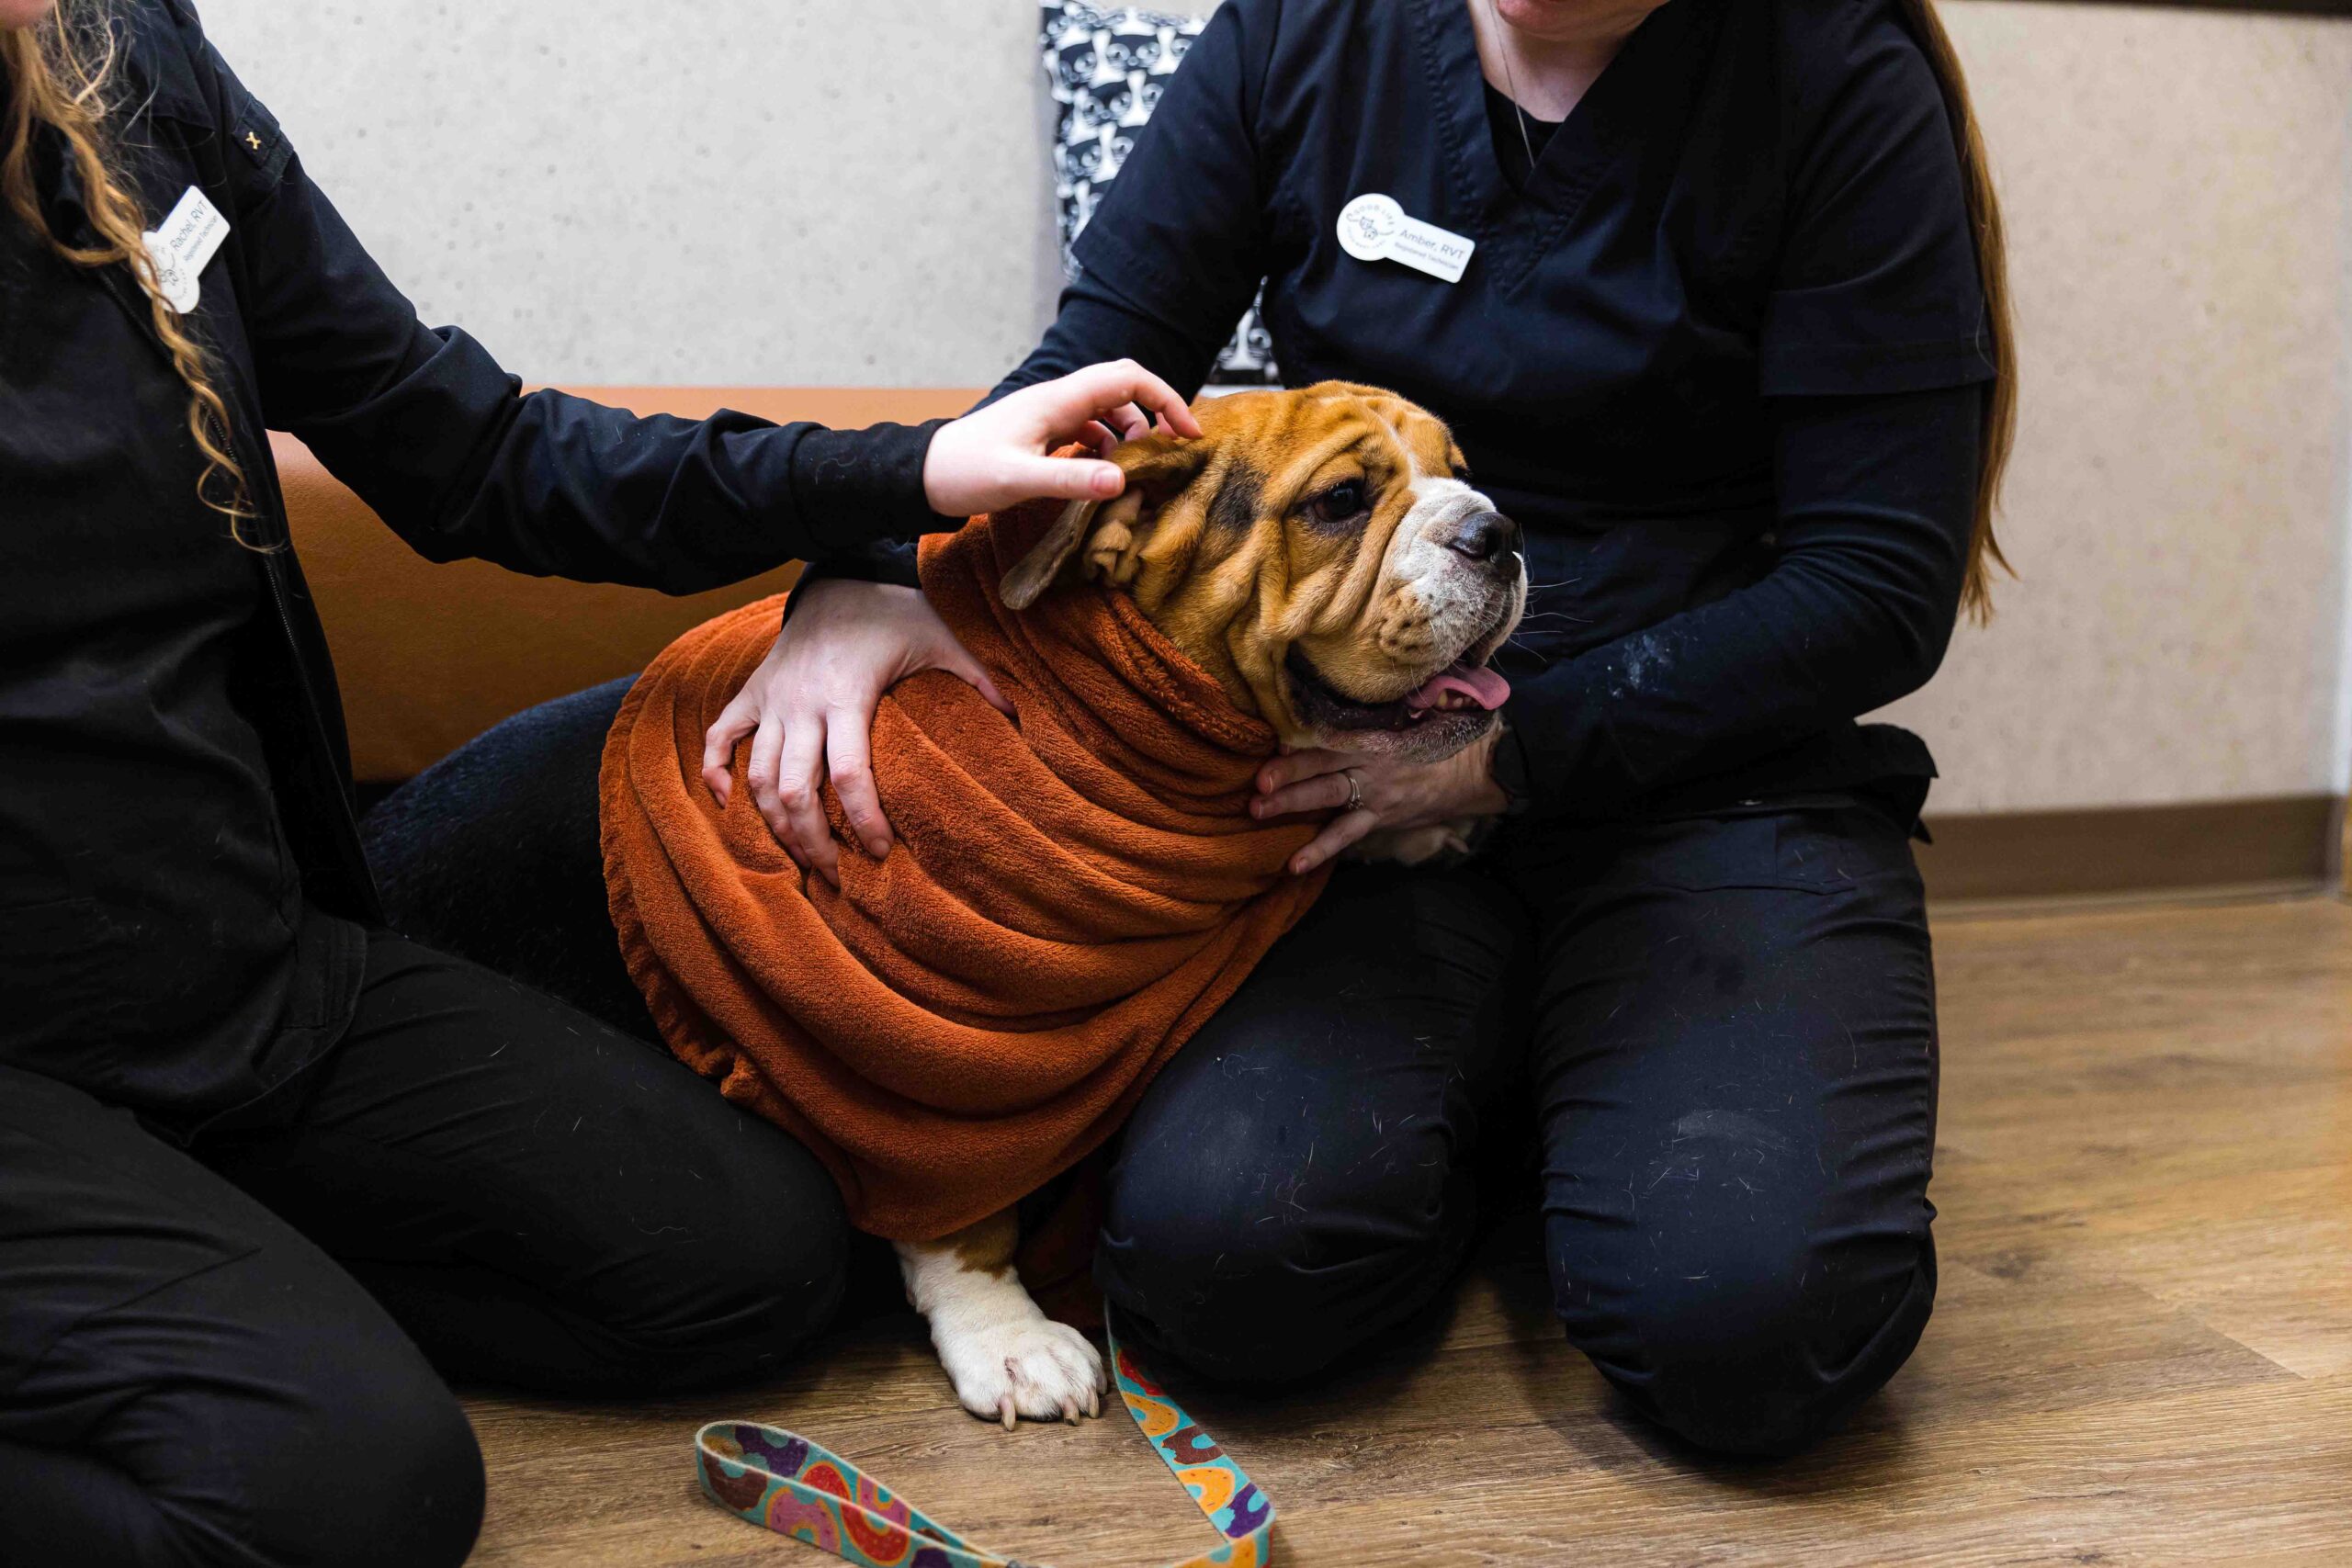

{"left": 1917, "top": 795, "right": 2343, "bottom": 903}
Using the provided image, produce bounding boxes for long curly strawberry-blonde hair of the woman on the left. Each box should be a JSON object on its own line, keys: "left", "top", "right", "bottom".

{"left": 0, "top": 0, "right": 254, "bottom": 546}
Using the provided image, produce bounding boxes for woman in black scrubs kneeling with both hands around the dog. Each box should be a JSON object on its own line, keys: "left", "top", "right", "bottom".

{"left": 700, "top": 0, "right": 2011, "bottom": 1455}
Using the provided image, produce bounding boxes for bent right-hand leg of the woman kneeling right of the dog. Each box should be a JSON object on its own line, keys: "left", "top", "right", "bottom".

{"left": 1536, "top": 807, "right": 1936, "bottom": 1455}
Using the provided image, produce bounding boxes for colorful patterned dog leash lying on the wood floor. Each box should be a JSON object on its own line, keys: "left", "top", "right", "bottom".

{"left": 694, "top": 1312, "right": 1275, "bottom": 1568}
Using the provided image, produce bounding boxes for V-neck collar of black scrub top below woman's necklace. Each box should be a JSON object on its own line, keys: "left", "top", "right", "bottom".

{"left": 1411, "top": 0, "right": 1724, "bottom": 291}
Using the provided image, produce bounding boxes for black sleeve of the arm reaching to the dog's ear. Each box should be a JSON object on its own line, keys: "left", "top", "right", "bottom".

{"left": 174, "top": 7, "right": 953, "bottom": 592}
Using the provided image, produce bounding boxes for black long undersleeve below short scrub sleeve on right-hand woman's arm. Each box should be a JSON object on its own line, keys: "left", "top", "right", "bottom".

{"left": 1505, "top": 386, "right": 1983, "bottom": 818}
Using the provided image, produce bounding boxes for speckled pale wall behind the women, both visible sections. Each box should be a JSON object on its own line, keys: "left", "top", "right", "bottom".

{"left": 205, "top": 0, "right": 2352, "bottom": 811}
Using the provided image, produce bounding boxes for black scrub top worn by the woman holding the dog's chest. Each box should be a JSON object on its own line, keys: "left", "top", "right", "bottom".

{"left": 931, "top": 0, "right": 1992, "bottom": 818}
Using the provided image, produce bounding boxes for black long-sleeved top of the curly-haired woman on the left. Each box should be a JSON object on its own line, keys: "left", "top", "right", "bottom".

{"left": 0, "top": 0, "right": 950, "bottom": 1140}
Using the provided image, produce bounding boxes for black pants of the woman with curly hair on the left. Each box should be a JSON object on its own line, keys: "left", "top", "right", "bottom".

{"left": 0, "top": 936, "right": 847, "bottom": 1568}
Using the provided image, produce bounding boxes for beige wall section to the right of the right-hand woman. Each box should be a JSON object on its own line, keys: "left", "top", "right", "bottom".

{"left": 1894, "top": 0, "right": 2352, "bottom": 811}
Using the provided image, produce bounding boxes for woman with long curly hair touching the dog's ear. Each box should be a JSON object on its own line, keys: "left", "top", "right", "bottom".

{"left": 0, "top": 0, "right": 1193, "bottom": 1568}
